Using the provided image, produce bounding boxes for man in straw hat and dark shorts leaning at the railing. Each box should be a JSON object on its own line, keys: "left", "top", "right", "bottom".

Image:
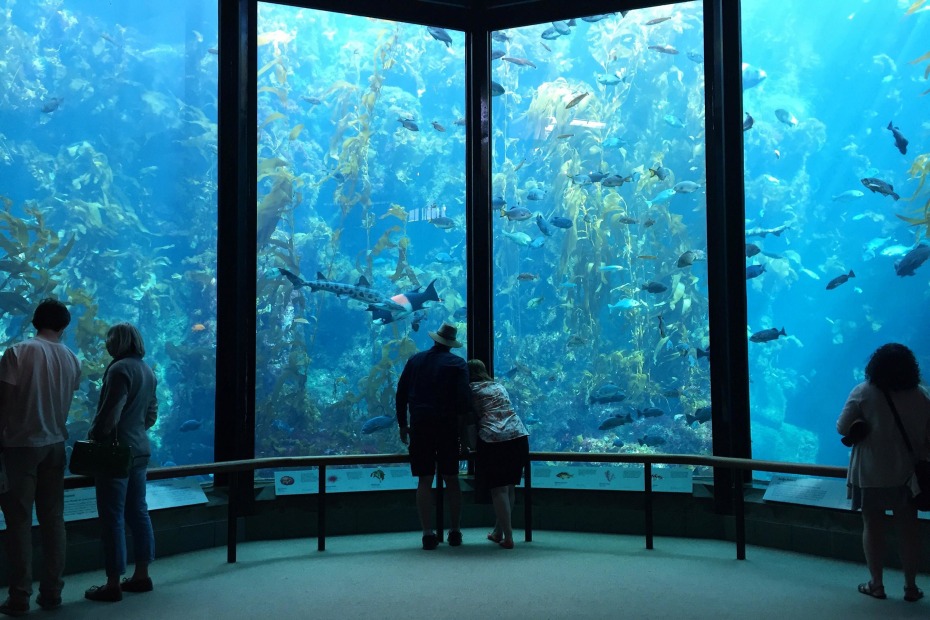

{"left": 396, "top": 323, "right": 471, "bottom": 551}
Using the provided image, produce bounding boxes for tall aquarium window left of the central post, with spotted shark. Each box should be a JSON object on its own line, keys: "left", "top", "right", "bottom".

{"left": 255, "top": 3, "right": 466, "bottom": 457}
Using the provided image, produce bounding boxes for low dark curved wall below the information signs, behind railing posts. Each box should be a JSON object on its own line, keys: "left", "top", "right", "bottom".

{"left": 0, "top": 485, "right": 930, "bottom": 587}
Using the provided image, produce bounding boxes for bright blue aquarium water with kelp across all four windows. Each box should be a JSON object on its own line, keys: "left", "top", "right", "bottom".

{"left": 0, "top": 0, "right": 930, "bottom": 464}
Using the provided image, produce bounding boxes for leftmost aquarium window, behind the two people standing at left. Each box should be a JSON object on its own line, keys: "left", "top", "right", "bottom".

{"left": 0, "top": 0, "right": 217, "bottom": 466}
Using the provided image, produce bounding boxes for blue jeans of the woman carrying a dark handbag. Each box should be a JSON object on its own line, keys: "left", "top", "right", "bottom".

{"left": 95, "top": 465, "right": 155, "bottom": 577}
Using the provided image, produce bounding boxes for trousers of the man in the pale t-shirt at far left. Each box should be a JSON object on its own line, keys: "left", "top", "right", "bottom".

{"left": 0, "top": 442, "right": 66, "bottom": 602}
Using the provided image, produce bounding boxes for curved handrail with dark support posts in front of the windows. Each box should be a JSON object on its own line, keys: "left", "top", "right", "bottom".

{"left": 65, "top": 452, "right": 846, "bottom": 563}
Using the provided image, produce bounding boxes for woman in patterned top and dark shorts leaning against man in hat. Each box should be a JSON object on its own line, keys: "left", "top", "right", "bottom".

{"left": 468, "top": 360, "right": 530, "bottom": 549}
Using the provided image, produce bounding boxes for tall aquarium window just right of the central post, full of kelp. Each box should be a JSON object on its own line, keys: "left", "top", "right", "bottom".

{"left": 491, "top": 2, "right": 711, "bottom": 453}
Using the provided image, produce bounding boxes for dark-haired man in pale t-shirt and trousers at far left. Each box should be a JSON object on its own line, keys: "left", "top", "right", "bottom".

{"left": 0, "top": 299, "right": 81, "bottom": 616}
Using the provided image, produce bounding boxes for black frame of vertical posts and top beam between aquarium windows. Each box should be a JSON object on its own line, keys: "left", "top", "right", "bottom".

{"left": 215, "top": 0, "right": 751, "bottom": 511}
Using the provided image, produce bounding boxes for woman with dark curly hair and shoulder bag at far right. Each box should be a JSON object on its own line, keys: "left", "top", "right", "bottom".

{"left": 836, "top": 343, "right": 930, "bottom": 602}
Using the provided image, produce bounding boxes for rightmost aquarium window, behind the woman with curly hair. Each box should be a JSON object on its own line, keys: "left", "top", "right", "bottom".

{"left": 742, "top": 0, "right": 930, "bottom": 465}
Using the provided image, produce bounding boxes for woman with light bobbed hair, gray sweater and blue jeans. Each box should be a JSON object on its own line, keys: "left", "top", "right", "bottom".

{"left": 84, "top": 323, "right": 158, "bottom": 602}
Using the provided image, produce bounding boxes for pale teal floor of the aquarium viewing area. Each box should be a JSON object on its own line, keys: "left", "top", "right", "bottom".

{"left": 14, "top": 530, "right": 930, "bottom": 620}
